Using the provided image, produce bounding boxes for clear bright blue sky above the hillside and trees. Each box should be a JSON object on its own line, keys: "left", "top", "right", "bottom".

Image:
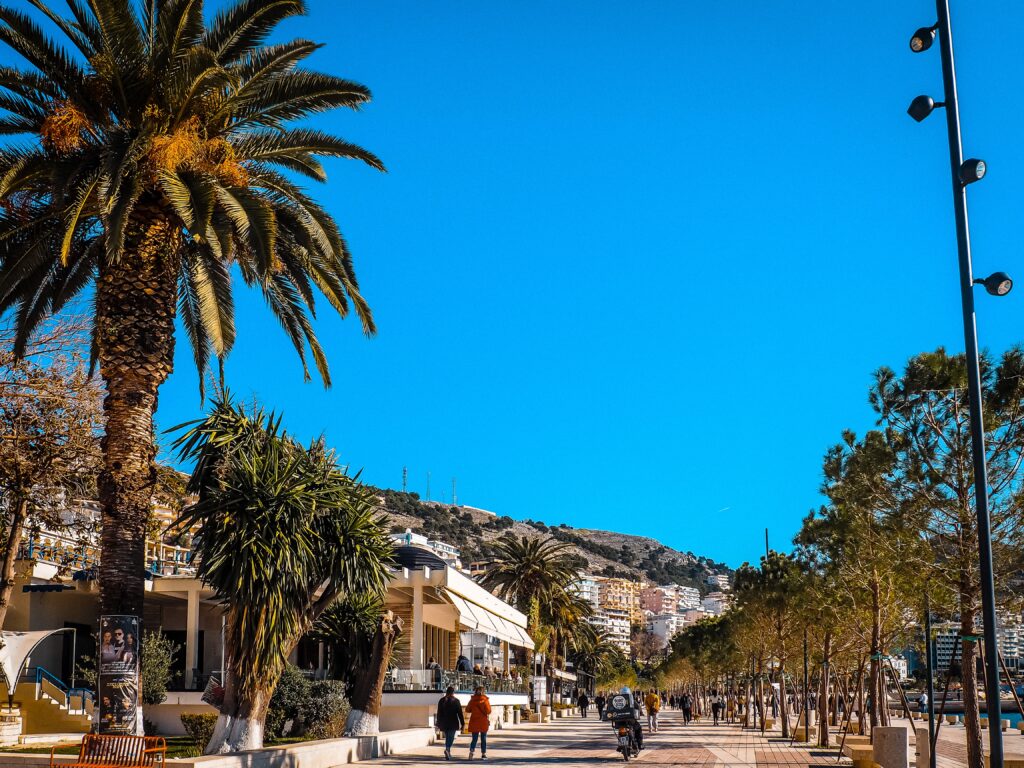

{"left": 146, "top": 0, "right": 1024, "bottom": 565}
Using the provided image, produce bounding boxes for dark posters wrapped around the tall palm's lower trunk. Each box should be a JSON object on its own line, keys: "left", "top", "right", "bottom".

{"left": 98, "top": 616, "right": 142, "bottom": 734}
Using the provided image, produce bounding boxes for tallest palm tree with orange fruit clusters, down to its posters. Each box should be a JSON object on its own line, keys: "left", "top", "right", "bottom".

{"left": 0, "top": 0, "right": 383, "bottom": 615}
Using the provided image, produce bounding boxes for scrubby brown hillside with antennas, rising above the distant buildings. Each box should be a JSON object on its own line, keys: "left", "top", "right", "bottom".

{"left": 379, "top": 490, "right": 732, "bottom": 594}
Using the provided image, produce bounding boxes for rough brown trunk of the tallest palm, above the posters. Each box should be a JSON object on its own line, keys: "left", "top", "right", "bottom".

{"left": 96, "top": 203, "right": 180, "bottom": 616}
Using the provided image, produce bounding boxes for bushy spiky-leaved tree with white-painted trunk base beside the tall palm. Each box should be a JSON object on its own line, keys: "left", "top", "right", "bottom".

{"left": 175, "top": 395, "right": 391, "bottom": 754}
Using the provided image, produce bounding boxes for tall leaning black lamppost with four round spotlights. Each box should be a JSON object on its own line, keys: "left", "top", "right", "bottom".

{"left": 907, "top": 0, "right": 1013, "bottom": 768}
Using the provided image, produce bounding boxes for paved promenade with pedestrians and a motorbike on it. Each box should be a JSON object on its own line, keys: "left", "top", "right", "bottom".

{"left": 371, "top": 712, "right": 850, "bottom": 768}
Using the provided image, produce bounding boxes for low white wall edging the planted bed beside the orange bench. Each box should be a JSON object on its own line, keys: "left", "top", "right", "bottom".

{"left": 0, "top": 728, "right": 434, "bottom": 768}
